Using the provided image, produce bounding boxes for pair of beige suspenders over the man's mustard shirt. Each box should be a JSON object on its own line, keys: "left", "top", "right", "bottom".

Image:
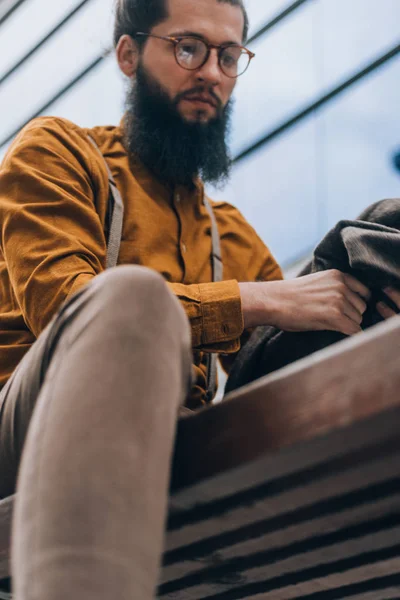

{"left": 88, "top": 136, "right": 223, "bottom": 402}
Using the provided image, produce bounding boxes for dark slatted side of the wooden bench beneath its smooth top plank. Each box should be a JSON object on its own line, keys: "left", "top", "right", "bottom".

{"left": 159, "top": 408, "right": 400, "bottom": 600}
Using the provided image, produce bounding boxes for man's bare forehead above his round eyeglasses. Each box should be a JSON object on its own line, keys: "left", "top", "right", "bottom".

{"left": 154, "top": 0, "right": 244, "bottom": 44}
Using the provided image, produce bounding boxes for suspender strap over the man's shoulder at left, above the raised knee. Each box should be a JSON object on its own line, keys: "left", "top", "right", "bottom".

{"left": 88, "top": 136, "right": 124, "bottom": 269}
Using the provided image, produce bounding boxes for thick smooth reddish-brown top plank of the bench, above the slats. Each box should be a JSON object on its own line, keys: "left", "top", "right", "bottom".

{"left": 172, "top": 317, "right": 400, "bottom": 490}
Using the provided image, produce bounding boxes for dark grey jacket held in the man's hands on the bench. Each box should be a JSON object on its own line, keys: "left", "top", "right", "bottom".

{"left": 225, "top": 199, "right": 400, "bottom": 392}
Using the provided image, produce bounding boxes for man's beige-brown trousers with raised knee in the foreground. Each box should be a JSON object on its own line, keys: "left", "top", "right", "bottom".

{"left": 0, "top": 266, "right": 192, "bottom": 600}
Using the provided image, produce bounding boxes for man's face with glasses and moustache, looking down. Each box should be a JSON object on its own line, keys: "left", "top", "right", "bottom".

{"left": 141, "top": 0, "right": 244, "bottom": 123}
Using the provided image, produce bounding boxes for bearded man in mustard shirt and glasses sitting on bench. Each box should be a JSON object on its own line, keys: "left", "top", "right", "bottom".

{"left": 0, "top": 0, "right": 400, "bottom": 600}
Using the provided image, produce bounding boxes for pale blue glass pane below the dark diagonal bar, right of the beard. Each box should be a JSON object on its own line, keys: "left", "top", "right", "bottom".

{"left": 216, "top": 58, "right": 400, "bottom": 264}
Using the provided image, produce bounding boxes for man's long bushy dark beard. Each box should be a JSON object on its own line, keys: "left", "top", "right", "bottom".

{"left": 124, "top": 65, "right": 232, "bottom": 187}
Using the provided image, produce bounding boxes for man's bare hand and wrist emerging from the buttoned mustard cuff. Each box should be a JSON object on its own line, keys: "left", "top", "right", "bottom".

{"left": 239, "top": 270, "right": 371, "bottom": 335}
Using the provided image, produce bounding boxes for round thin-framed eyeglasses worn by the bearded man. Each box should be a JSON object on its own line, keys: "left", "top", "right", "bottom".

{"left": 135, "top": 32, "right": 255, "bottom": 79}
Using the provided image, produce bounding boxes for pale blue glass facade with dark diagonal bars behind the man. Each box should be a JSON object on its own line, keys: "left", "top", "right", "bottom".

{"left": 0, "top": 0, "right": 400, "bottom": 266}
